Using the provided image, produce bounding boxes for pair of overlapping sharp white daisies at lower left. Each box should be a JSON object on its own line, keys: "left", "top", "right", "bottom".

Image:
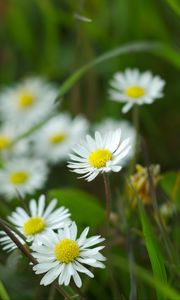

{"left": 0, "top": 195, "right": 105, "bottom": 287}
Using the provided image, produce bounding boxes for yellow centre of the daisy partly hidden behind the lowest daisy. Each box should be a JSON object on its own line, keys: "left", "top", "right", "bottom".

{"left": 23, "top": 217, "right": 46, "bottom": 235}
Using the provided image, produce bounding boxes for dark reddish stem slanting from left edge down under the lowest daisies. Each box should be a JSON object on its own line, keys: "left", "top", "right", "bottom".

{"left": 0, "top": 219, "right": 80, "bottom": 300}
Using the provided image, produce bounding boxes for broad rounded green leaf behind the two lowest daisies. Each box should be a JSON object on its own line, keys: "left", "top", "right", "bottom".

{"left": 48, "top": 188, "right": 105, "bottom": 229}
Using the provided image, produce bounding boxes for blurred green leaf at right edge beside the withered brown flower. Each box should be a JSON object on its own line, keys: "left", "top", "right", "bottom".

{"left": 160, "top": 172, "right": 180, "bottom": 202}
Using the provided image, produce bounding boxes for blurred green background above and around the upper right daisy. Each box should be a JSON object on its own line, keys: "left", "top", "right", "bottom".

{"left": 0, "top": 0, "right": 180, "bottom": 170}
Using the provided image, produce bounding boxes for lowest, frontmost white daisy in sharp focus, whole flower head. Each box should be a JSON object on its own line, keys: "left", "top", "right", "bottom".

{"left": 32, "top": 222, "right": 106, "bottom": 287}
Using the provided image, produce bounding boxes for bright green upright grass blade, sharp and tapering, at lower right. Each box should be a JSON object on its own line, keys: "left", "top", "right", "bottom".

{"left": 139, "top": 201, "right": 167, "bottom": 300}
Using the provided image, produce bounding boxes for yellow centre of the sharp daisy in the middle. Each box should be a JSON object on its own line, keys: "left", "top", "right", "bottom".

{"left": 88, "top": 149, "right": 112, "bottom": 169}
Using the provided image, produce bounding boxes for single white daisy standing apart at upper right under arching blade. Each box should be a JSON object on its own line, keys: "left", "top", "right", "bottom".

{"left": 109, "top": 69, "right": 165, "bottom": 113}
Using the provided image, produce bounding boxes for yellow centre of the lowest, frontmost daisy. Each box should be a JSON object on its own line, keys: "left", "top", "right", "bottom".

{"left": 54, "top": 239, "right": 80, "bottom": 264}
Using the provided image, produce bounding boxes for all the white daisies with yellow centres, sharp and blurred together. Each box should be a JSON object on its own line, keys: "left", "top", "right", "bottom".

{"left": 0, "top": 69, "right": 164, "bottom": 287}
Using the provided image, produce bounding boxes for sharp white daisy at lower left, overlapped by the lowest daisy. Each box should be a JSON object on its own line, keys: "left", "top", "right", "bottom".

{"left": 3, "top": 195, "right": 71, "bottom": 246}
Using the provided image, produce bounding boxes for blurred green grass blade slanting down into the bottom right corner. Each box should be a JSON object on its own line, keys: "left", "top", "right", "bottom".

{"left": 111, "top": 255, "right": 180, "bottom": 300}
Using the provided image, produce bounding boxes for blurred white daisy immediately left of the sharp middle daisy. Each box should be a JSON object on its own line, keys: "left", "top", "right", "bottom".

{"left": 33, "top": 113, "right": 88, "bottom": 163}
